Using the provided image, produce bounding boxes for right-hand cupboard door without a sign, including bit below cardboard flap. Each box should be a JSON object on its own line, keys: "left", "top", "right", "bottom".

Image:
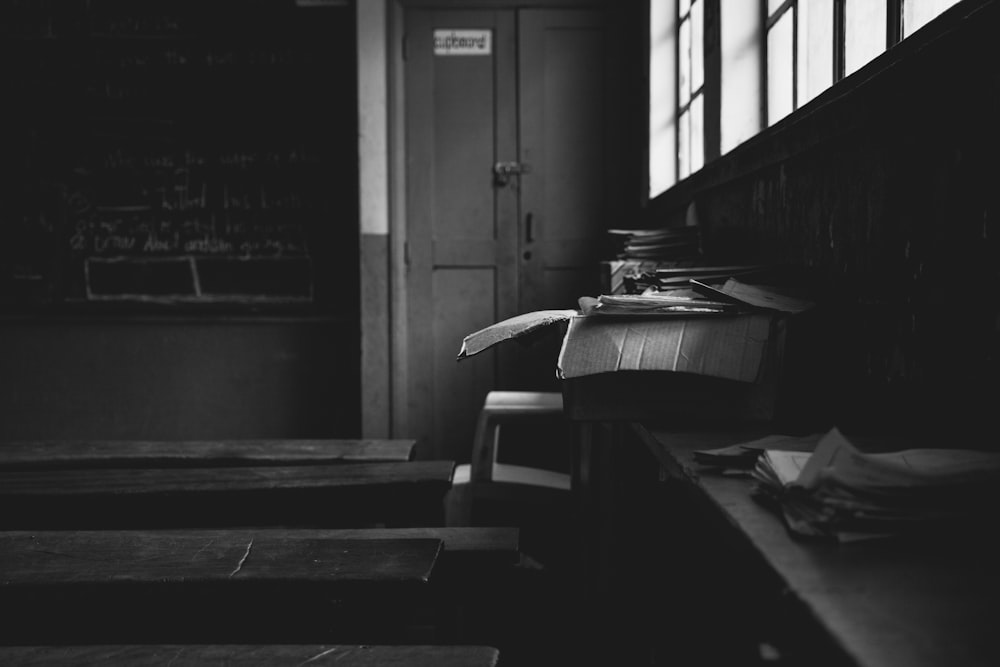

{"left": 503, "top": 10, "right": 625, "bottom": 391}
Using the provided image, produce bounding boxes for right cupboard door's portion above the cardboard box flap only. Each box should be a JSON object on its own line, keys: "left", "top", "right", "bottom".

{"left": 518, "top": 10, "right": 614, "bottom": 310}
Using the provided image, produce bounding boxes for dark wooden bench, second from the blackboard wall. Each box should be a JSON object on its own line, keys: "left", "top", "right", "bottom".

{"left": 0, "top": 461, "right": 455, "bottom": 530}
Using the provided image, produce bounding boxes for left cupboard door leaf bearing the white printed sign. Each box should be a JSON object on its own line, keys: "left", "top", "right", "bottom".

{"left": 404, "top": 9, "right": 517, "bottom": 460}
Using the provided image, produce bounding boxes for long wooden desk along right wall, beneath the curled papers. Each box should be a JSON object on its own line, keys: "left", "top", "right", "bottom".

{"left": 572, "top": 424, "right": 1000, "bottom": 667}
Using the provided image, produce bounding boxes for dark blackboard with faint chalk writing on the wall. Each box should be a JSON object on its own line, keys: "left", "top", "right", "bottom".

{"left": 0, "top": 0, "right": 358, "bottom": 310}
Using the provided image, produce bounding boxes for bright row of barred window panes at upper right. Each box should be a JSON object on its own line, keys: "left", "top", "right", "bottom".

{"left": 649, "top": 0, "right": 958, "bottom": 197}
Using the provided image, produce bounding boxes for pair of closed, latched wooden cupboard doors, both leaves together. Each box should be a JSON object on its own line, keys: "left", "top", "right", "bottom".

{"left": 404, "top": 8, "right": 620, "bottom": 460}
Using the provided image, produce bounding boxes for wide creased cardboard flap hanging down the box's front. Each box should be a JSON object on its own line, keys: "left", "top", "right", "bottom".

{"left": 558, "top": 314, "right": 774, "bottom": 382}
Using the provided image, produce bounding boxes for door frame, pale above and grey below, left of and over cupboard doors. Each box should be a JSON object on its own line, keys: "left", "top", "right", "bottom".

{"left": 357, "top": 0, "right": 617, "bottom": 444}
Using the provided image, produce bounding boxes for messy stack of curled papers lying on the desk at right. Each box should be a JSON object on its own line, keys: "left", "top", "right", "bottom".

{"left": 753, "top": 429, "right": 1000, "bottom": 541}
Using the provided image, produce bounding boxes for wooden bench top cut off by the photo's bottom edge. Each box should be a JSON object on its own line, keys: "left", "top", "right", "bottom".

{"left": 0, "top": 644, "right": 499, "bottom": 667}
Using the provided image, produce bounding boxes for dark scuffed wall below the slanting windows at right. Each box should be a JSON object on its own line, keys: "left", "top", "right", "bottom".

{"left": 650, "top": 1, "right": 1000, "bottom": 443}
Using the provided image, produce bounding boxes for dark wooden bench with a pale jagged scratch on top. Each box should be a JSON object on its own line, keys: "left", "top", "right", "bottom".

{"left": 0, "top": 529, "right": 443, "bottom": 644}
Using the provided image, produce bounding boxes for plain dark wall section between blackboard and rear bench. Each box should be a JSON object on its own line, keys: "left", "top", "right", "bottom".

{"left": 0, "top": 319, "right": 360, "bottom": 440}
